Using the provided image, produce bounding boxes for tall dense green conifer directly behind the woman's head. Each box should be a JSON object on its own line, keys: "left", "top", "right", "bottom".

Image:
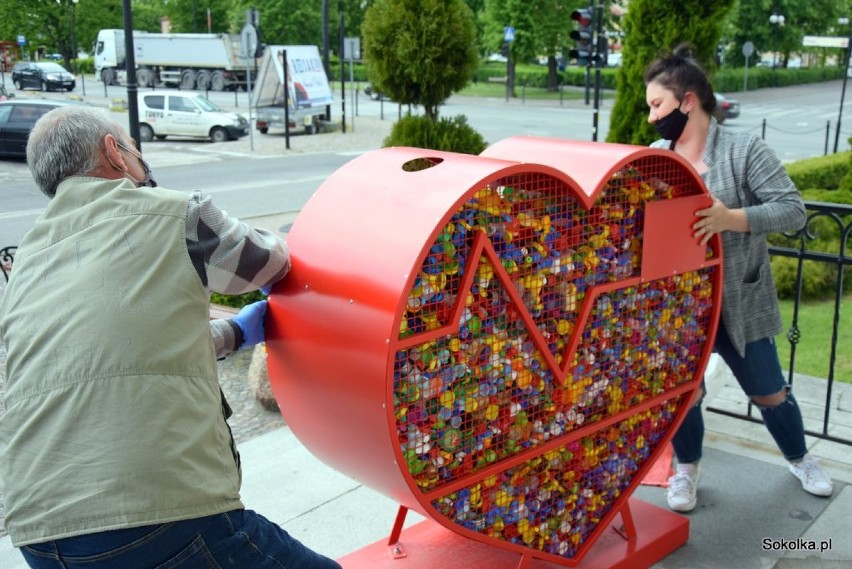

{"left": 607, "top": 0, "right": 736, "bottom": 145}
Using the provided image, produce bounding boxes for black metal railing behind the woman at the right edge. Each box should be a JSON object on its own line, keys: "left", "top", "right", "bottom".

{"left": 707, "top": 202, "right": 852, "bottom": 446}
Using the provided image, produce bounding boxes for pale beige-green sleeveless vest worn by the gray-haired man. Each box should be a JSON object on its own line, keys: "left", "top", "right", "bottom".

{"left": 0, "top": 177, "right": 242, "bottom": 546}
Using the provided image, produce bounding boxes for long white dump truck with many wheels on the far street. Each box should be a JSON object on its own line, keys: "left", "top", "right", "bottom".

{"left": 95, "top": 29, "right": 257, "bottom": 91}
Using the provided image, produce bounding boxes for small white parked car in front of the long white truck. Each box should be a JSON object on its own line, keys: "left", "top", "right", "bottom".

{"left": 139, "top": 92, "right": 249, "bottom": 142}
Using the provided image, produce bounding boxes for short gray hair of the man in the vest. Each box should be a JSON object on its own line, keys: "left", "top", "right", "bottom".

{"left": 27, "top": 105, "right": 126, "bottom": 198}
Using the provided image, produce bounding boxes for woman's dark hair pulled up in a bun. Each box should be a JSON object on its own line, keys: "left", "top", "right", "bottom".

{"left": 644, "top": 42, "right": 716, "bottom": 115}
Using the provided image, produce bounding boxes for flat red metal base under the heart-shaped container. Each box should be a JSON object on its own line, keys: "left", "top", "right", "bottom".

{"left": 337, "top": 498, "right": 689, "bottom": 569}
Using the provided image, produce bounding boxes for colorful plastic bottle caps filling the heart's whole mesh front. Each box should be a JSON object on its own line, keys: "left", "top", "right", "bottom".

{"left": 393, "top": 161, "right": 718, "bottom": 557}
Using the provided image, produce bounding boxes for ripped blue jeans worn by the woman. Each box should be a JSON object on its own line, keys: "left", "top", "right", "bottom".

{"left": 672, "top": 324, "right": 807, "bottom": 464}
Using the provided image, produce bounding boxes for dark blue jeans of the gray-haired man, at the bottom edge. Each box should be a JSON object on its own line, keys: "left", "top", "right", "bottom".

{"left": 21, "top": 510, "right": 340, "bottom": 569}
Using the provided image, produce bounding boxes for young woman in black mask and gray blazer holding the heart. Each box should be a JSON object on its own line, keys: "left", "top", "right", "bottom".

{"left": 645, "top": 44, "right": 833, "bottom": 512}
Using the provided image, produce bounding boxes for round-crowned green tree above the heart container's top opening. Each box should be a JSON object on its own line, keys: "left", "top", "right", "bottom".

{"left": 361, "top": 0, "right": 478, "bottom": 119}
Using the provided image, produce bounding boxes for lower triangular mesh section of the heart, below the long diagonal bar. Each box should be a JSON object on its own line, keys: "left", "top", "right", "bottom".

{"left": 432, "top": 399, "right": 680, "bottom": 558}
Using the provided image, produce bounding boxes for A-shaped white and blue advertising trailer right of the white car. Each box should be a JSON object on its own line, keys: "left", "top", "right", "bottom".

{"left": 252, "top": 45, "right": 333, "bottom": 134}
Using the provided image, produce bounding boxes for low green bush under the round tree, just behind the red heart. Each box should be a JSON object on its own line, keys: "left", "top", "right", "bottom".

{"left": 383, "top": 115, "right": 488, "bottom": 154}
